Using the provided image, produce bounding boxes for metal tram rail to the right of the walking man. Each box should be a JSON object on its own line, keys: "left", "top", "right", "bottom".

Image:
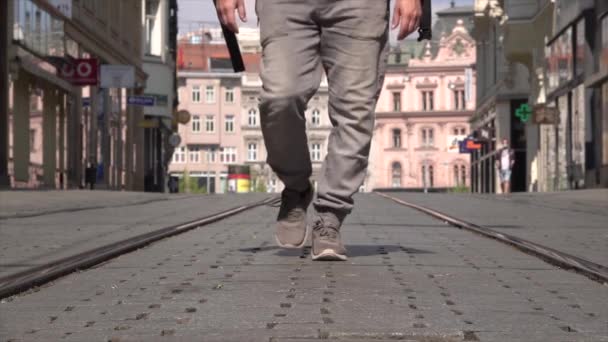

{"left": 375, "top": 192, "right": 608, "bottom": 284}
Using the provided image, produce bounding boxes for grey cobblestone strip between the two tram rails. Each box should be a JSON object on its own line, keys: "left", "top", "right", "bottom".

{"left": 0, "top": 194, "right": 608, "bottom": 342}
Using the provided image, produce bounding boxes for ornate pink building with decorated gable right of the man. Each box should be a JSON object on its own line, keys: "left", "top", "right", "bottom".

{"left": 365, "top": 16, "right": 476, "bottom": 189}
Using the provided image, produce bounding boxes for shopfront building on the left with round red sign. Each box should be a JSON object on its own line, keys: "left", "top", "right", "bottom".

{"left": 0, "top": 0, "right": 147, "bottom": 190}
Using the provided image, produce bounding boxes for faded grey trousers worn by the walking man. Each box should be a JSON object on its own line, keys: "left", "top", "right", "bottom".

{"left": 256, "top": 0, "right": 389, "bottom": 214}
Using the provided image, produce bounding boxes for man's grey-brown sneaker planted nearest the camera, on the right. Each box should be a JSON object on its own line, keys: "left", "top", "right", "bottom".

{"left": 311, "top": 212, "right": 347, "bottom": 261}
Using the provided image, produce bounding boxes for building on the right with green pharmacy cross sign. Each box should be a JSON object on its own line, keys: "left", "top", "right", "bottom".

{"left": 472, "top": 0, "right": 608, "bottom": 192}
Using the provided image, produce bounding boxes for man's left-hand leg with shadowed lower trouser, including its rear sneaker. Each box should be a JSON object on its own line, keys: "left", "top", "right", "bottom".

{"left": 256, "top": 0, "right": 322, "bottom": 248}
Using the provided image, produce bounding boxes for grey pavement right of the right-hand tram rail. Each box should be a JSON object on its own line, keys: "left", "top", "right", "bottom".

{"left": 390, "top": 189, "right": 608, "bottom": 267}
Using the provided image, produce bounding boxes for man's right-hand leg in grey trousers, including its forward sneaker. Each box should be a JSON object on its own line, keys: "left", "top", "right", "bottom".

{"left": 312, "top": 0, "right": 389, "bottom": 260}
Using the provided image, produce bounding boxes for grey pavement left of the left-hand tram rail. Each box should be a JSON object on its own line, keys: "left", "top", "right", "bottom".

{"left": 0, "top": 191, "right": 269, "bottom": 276}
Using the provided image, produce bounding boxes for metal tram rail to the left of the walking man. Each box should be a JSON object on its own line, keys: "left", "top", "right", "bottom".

{"left": 0, "top": 197, "right": 279, "bottom": 299}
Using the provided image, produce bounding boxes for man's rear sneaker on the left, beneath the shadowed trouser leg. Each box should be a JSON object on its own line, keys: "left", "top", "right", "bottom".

{"left": 274, "top": 186, "right": 314, "bottom": 248}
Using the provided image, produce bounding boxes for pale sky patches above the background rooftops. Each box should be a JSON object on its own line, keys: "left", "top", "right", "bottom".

{"left": 178, "top": 0, "right": 473, "bottom": 33}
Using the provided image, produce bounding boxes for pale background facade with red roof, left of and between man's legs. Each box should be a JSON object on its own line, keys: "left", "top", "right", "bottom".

{"left": 169, "top": 28, "right": 331, "bottom": 193}
